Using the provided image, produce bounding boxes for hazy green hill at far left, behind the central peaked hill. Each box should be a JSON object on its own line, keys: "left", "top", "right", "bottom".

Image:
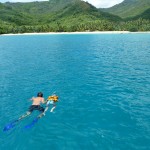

{"left": 0, "top": 0, "right": 80, "bottom": 25}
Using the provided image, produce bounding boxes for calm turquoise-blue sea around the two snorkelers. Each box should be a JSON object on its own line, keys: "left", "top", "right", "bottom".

{"left": 0, "top": 34, "right": 150, "bottom": 150}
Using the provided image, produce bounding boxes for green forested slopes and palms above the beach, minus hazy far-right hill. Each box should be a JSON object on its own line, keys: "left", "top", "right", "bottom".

{"left": 0, "top": 0, "right": 150, "bottom": 34}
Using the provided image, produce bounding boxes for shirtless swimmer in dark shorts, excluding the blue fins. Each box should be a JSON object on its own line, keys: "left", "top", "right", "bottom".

{"left": 18, "top": 92, "right": 45, "bottom": 120}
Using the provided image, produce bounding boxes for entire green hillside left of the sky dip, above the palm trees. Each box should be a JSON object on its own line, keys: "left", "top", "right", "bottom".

{"left": 0, "top": 0, "right": 121, "bottom": 25}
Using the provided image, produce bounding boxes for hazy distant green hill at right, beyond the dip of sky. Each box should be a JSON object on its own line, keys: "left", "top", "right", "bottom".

{"left": 101, "top": 0, "right": 150, "bottom": 18}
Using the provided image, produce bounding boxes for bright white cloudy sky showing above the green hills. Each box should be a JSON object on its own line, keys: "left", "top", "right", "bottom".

{"left": 0, "top": 0, "right": 123, "bottom": 8}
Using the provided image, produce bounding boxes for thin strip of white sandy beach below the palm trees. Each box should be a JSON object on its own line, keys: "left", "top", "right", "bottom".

{"left": 0, "top": 31, "right": 150, "bottom": 36}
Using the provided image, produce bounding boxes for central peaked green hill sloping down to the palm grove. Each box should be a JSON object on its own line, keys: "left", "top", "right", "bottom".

{"left": 43, "top": 1, "right": 121, "bottom": 24}
